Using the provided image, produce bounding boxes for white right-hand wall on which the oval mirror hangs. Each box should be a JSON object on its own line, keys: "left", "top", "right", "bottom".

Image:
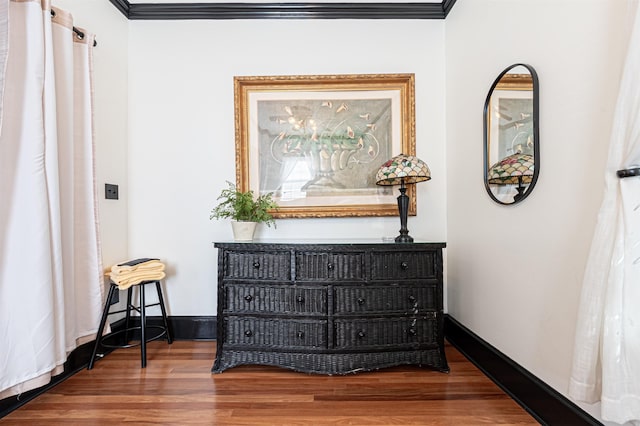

{"left": 446, "top": 0, "right": 629, "bottom": 417}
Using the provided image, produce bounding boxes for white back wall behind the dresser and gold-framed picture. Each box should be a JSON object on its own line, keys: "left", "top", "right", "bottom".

{"left": 128, "top": 20, "right": 446, "bottom": 315}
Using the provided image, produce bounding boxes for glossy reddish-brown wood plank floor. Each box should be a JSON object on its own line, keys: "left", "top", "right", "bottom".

{"left": 0, "top": 341, "right": 538, "bottom": 426}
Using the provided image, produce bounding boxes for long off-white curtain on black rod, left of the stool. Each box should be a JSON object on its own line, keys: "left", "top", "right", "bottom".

{"left": 0, "top": 0, "right": 104, "bottom": 398}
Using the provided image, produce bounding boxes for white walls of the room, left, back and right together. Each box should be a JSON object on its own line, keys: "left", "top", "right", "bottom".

{"left": 47, "top": 0, "right": 630, "bottom": 418}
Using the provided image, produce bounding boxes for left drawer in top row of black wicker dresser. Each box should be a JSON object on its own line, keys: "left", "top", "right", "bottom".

{"left": 223, "top": 251, "right": 291, "bottom": 281}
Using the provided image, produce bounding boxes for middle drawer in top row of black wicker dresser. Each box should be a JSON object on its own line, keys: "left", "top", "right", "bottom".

{"left": 296, "top": 252, "right": 365, "bottom": 281}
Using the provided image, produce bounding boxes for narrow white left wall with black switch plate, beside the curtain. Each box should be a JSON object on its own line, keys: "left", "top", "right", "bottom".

{"left": 53, "top": 0, "right": 129, "bottom": 267}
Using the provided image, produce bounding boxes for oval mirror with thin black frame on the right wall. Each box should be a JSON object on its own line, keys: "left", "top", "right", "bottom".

{"left": 483, "top": 64, "right": 540, "bottom": 204}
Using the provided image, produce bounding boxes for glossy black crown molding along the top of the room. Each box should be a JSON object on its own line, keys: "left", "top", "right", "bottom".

{"left": 109, "top": 0, "right": 456, "bottom": 20}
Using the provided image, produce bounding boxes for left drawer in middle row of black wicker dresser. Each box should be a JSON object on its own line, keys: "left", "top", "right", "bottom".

{"left": 224, "top": 283, "right": 327, "bottom": 315}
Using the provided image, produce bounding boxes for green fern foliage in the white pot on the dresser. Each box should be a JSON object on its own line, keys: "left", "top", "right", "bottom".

{"left": 209, "top": 181, "right": 278, "bottom": 227}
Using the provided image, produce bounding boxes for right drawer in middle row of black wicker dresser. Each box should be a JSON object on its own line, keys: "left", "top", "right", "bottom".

{"left": 333, "top": 285, "right": 438, "bottom": 315}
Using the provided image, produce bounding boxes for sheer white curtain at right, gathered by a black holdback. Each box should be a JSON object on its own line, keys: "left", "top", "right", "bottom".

{"left": 569, "top": 0, "right": 640, "bottom": 424}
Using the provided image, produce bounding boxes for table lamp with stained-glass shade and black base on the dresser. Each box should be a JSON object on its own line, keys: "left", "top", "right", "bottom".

{"left": 376, "top": 154, "right": 431, "bottom": 243}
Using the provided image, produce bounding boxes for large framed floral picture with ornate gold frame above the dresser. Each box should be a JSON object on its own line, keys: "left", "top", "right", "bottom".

{"left": 234, "top": 74, "right": 416, "bottom": 218}
